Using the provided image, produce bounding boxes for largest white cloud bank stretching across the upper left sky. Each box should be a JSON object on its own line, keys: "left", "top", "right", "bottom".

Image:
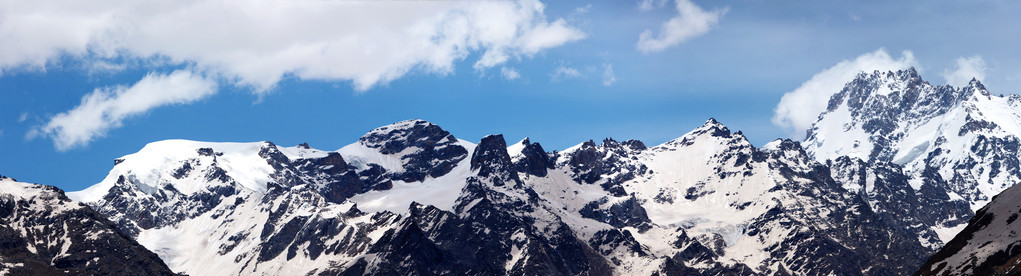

{"left": 0, "top": 0, "right": 585, "bottom": 92}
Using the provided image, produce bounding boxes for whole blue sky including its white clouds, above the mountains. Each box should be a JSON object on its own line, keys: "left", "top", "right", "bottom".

{"left": 0, "top": 0, "right": 1021, "bottom": 190}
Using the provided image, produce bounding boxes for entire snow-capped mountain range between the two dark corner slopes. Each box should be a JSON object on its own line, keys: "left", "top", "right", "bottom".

{"left": 5, "top": 68, "right": 1021, "bottom": 275}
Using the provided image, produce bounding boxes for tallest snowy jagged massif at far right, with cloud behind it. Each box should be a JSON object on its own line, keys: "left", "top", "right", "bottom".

{"left": 805, "top": 68, "right": 1021, "bottom": 209}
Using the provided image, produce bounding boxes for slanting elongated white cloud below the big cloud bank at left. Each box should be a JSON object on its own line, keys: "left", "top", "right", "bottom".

{"left": 28, "top": 71, "right": 216, "bottom": 150}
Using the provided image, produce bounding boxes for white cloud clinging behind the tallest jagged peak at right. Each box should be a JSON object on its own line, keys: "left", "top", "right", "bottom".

{"left": 773, "top": 49, "right": 918, "bottom": 139}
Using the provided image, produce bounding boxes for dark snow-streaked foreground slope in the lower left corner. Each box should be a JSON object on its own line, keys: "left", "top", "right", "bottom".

{"left": 0, "top": 177, "right": 174, "bottom": 275}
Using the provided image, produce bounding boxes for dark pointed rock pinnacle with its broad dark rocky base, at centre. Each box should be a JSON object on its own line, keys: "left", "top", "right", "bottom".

{"left": 348, "top": 135, "right": 613, "bottom": 275}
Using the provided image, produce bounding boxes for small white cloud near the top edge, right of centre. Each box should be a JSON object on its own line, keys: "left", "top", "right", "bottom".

{"left": 636, "top": 0, "right": 727, "bottom": 53}
